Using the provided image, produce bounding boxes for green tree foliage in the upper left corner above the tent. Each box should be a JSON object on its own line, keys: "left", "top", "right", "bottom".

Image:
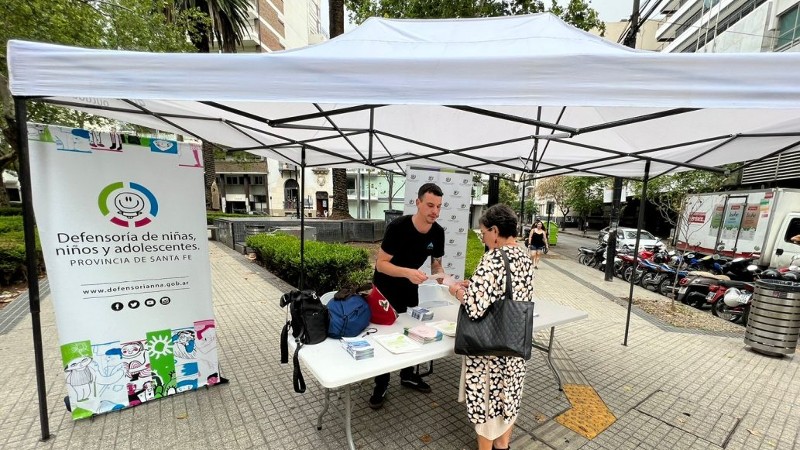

{"left": 0, "top": 0, "right": 198, "bottom": 206}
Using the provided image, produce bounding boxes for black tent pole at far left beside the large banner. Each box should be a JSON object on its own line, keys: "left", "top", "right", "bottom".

{"left": 14, "top": 97, "right": 50, "bottom": 441}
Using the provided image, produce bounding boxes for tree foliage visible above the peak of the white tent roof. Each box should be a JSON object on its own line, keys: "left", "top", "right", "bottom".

{"left": 345, "top": 0, "right": 605, "bottom": 31}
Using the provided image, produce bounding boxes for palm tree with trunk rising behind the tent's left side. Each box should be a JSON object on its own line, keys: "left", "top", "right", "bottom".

{"left": 171, "top": 0, "right": 251, "bottom": 209}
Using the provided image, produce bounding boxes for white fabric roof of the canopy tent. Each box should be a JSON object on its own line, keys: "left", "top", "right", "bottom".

{"left": 8, "top": 14, "right": 800, "bottom": 177}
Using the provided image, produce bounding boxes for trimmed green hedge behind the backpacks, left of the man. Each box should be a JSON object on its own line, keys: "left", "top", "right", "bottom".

{"left": 247, "top": 234, "right": 373, "bottom": 293}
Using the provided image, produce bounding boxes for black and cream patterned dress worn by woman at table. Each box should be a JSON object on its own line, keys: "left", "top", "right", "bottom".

{"left": 460, "top": 245, "right": 533, "bottom": 439}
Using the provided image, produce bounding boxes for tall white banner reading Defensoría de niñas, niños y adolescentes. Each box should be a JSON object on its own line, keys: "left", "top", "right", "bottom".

{"left": 28, "top": 124, "right": 219, "bottom": 419}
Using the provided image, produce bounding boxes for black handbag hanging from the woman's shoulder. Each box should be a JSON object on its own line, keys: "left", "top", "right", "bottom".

{"left": 455, "top": 249, "right": 533, "bottom": 360}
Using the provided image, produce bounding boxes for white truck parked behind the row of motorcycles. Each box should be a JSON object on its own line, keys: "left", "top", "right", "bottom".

{"left": 675, "top": 188, "right": 800, "bottom": 268}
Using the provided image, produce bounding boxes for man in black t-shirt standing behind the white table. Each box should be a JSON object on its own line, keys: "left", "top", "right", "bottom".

{"left": 369, "top": 183, "right": 444, "bottom": 409}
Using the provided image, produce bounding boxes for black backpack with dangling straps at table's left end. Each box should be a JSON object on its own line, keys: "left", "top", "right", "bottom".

{"left": 281, "top": 290, "right": 329, "bottom": 394}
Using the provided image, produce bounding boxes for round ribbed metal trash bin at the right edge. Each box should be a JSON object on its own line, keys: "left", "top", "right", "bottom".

{"left": 744, "top": 280, "right": 800, "bottom": 356}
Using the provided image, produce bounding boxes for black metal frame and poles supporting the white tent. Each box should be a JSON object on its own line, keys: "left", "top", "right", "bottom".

{"left": 13, "top": 96, "right": 800, "bottom": 440}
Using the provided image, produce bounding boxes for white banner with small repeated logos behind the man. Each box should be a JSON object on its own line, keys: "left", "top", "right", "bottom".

{"left": 403, "top": 166, "right": 472, "bottom": 280}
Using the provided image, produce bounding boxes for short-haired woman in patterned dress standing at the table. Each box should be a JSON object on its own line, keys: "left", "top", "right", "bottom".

{"left": 450, "top": 205, "right": 533, "bottom": 450}
